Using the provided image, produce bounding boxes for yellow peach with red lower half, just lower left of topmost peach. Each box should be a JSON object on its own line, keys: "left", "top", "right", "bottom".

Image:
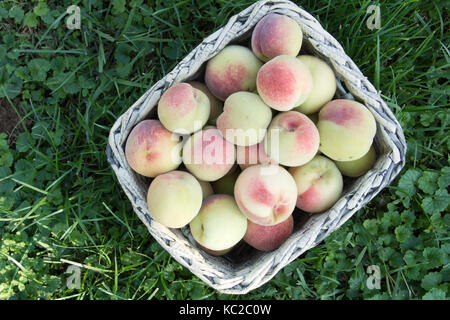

{"left": 205, "top": 45, "right": 262, "bottom": 101}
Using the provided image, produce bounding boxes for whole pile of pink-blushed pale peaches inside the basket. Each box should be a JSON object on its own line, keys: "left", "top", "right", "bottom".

{"left": 125, "top": 14, "right": 376, "bottom": 255}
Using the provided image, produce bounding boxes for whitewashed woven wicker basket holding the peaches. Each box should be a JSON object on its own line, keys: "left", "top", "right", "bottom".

{"left": 107, "top": 0, "right": 406, "bottom": 294}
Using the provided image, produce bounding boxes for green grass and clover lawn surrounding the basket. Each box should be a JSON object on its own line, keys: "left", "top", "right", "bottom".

{"left": 0, "top": 0, "right": 450, "bottom": 299}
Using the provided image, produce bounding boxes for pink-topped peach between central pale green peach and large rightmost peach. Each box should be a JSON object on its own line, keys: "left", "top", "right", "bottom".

{"left": 264, "top": 111, "right": 320, "bottom": 167}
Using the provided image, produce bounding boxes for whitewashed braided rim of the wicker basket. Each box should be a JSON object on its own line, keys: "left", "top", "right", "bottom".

{"left": 106, "top": 0, "right": 406, "bottom": 294}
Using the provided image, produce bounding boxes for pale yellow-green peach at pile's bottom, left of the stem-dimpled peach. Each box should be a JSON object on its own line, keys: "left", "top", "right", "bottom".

{"left": 189, "top": 194, "right": 247, "bottom": 251}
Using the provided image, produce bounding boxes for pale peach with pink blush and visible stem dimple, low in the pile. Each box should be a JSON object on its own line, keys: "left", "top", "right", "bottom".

{"left": 234, "top": 165, "right": 297, "bottom": 226}
